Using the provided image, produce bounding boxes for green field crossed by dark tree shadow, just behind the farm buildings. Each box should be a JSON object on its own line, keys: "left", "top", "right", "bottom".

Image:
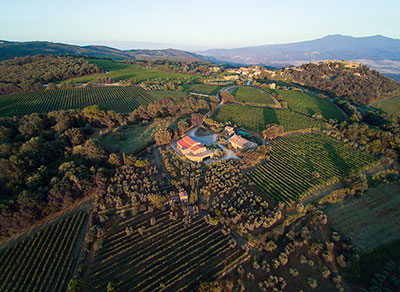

{"left": 211, "top": 104, "right": 323, "bottom": 132}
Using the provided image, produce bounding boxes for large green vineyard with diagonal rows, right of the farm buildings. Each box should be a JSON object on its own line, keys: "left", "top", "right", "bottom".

{"left": 247, "top": 134, "right": 376, "bottom": 205}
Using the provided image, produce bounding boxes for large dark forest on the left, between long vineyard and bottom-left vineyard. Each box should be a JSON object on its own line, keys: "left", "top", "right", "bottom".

{"left": 0, "top": 94, "right": 210, "bottom": 240}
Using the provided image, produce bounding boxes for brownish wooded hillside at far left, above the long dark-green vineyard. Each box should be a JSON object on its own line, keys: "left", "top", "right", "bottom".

{"left": 0, "top": 55, "right": 102, "bottom": 94}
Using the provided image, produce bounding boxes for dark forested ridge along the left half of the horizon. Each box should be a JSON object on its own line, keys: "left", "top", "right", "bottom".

{"left": 0, "top": 41, "right": 206, "bottom": 62}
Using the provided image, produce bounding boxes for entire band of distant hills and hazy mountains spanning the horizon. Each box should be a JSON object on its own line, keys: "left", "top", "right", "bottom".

{"left": 0, "top": 35, "right": 400, "bottom": 75}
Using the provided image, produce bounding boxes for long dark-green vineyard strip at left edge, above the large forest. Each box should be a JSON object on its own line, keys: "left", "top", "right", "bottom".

{"left": 0, "top": 87, "right": 153, "bottom": 116}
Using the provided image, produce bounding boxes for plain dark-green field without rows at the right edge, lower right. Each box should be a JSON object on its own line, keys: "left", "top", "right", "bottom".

{"left": 325, "top": 182, "right": 400, "bottom": 250}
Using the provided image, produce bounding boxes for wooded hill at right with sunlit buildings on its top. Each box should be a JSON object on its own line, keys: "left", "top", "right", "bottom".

{"left": 282, "top": 62, "right": 400, "bottom": 105}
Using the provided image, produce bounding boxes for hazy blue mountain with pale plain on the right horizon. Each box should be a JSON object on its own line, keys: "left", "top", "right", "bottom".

{"left": 200, "top": 35, "right": 400, "bottom": 74}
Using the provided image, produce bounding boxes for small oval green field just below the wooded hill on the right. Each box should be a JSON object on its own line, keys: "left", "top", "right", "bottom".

{"left": 277, "top": 90, "right": 345, "bottom": 121}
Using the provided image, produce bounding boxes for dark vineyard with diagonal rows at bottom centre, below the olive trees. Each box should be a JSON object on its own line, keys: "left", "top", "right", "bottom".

{"left": 85, "top": 211, "right": 247, "bottom": 291}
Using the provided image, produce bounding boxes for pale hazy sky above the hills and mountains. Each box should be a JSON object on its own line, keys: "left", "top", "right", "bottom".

{"left": 0, "top": 0, "right": 400, "bottom": 49}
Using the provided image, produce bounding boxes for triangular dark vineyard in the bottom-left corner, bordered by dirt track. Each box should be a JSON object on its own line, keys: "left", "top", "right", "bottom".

{"left": 0, "top": 212, "right": 86, "bottom": 292}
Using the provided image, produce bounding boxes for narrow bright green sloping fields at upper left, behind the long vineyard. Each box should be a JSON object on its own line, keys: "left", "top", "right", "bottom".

{"left": 67, "top": 59, "right": 197, "bottom": 83}
